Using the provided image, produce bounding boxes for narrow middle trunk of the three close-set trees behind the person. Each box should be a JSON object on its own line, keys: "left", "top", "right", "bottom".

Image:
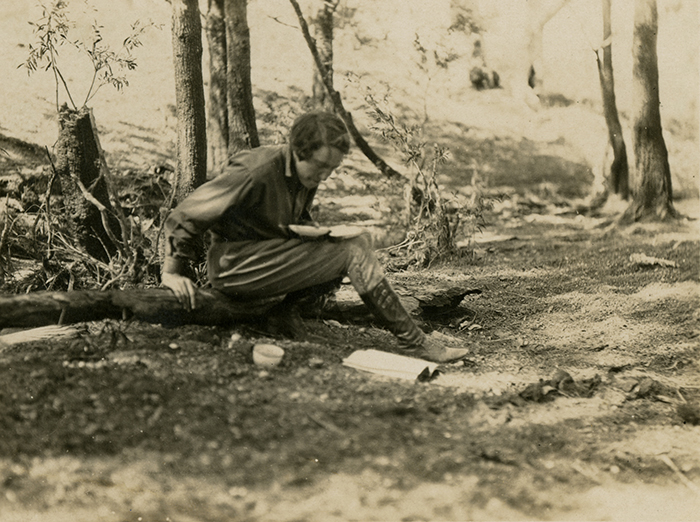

{"left": 206, "top": 0, "right": 229, "bottom": 171}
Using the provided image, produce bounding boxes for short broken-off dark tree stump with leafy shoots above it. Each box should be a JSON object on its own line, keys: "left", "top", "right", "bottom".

{"left": 56, "top": 104, "right": 120, "bottom": 261}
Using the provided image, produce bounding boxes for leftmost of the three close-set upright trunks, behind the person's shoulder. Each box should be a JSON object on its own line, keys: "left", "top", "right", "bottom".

{"left": 172, "top": 0, "right": 207, "bottom": 202}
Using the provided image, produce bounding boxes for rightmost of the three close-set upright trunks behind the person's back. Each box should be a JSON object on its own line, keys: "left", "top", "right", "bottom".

{"left": 224, "top": 0, "right": 260, "bottom": 156}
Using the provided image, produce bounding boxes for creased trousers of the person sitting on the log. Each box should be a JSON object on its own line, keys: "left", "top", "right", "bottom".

{"left": 207, "top": 233, "right": 384, "bottom": 298}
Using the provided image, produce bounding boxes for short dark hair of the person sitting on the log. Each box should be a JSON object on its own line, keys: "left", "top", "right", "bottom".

{"left": 289, "top": 111, "right": 350, "bottom": 161}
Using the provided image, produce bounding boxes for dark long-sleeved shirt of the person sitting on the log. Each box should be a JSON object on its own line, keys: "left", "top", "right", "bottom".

{"left": 163, "top": 142, "right": 316, "bottom": 273}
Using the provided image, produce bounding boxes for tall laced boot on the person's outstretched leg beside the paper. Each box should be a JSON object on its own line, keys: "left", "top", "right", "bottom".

{"left": 360, "top": 278, "right": 469, "bottom": 363}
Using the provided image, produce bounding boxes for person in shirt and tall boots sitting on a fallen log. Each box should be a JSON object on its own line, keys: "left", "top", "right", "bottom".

{"left": 162, "top": 112, "right": 468, "bottom": 363}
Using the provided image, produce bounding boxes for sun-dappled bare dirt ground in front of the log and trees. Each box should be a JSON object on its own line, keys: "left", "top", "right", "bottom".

{"left": 0, "top": 193, "right": 700, "bottom": 522}
